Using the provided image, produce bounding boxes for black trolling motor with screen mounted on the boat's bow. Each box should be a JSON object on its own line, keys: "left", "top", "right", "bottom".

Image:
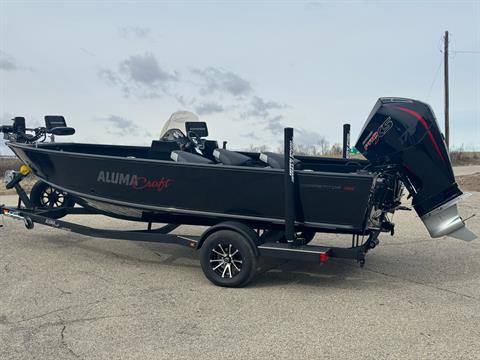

{"left": 0, "top": 115, "right": 75, "bottom": 144}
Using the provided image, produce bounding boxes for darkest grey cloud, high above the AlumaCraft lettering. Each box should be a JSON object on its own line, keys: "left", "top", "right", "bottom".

{"left": 98, "top": 53, "right": 179, "bottom": 99}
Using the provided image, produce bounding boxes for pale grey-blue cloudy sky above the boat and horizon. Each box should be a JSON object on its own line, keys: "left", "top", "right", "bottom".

{"left": 0, "top": 0, "right": 480, "bottom": 150}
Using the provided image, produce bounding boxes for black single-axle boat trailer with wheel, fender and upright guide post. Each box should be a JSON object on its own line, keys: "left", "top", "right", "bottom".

{"left": 0, "top": 128, "right": 382, "bottom": 287}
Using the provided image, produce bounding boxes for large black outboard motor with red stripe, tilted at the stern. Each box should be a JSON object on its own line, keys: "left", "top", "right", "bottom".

{"left": 355, "top": 98, "right": 476, "bottom": 240}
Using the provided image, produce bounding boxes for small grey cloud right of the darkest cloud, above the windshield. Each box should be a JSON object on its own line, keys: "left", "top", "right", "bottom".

{"left": 191, "top": 66, "right": 253, "bottom": 96}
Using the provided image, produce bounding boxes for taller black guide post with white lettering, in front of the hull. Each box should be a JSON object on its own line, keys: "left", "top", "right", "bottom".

{"left": 283, "top": 128, "right": 295, "bottom": 243}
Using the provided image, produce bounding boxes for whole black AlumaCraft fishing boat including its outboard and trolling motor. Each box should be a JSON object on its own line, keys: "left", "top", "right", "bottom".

{"left": 2, "top": 98, "right": 476, "bottom": 286}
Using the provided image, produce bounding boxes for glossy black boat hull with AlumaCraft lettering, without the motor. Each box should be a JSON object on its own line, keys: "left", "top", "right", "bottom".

{"left": 8, "top": 143, "right": 377, "bottom": 233}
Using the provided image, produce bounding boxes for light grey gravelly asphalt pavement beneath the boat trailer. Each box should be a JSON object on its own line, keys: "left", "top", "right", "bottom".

{"left": 0, "top": 193, "right": 480, "bottom": 359}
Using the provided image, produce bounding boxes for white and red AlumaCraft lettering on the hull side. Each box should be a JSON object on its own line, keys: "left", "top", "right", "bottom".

{"left": 97, "top": 170, "right": 173, "bottom": 191}
